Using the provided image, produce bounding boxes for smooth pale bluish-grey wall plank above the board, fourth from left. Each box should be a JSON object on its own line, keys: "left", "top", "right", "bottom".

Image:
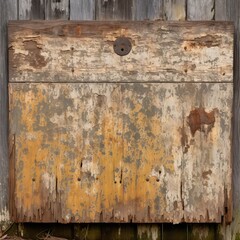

{"left": 70, "top": 0, "right": 95, "bottom": 20}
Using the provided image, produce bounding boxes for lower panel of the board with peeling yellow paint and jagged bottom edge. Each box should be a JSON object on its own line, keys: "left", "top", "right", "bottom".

{"left": 9, "top": 83, "right": 232, "bottom": 223}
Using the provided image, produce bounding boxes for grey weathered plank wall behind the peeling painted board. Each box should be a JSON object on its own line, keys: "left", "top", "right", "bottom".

{"left": 0, "top": 0, "right": 240, "bottom": 239}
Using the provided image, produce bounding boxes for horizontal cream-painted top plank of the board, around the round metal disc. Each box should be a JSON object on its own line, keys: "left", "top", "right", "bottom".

{"left": 9, "top": 21, "right": 233, "bottom": 82}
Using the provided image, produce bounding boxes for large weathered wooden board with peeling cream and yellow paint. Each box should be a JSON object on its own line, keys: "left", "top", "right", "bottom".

{"left": 9, "top": 21, "right": 233, "bottom": 223}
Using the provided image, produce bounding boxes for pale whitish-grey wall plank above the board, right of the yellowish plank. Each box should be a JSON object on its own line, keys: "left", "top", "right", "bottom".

{"left": 187, "top": 0, "right": 214, "bottom": 20}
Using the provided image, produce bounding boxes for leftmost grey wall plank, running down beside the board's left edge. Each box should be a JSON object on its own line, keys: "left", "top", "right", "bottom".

{"left": 0, "top": 0, "right": 17, "bottom": 222}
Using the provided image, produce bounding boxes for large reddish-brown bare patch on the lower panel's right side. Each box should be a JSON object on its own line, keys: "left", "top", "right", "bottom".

{"left": 188, "top": 107, "right": 215, "bottom": 136}
